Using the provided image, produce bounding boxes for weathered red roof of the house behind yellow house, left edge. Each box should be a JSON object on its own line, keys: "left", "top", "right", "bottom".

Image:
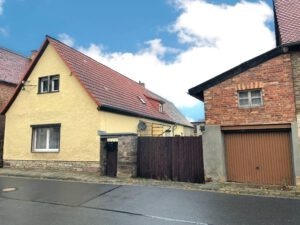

{"left": 0, "top": 47, "right": 30, "bottom": 84}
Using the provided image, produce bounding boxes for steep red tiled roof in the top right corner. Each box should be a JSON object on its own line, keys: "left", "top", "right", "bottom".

{"left": 274, "top": 0, "right": 300, "bottom": 46}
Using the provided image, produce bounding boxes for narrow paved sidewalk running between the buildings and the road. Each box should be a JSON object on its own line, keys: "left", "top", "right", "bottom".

{"left": 0, "top": 168, "right": 300, "bottom": 199}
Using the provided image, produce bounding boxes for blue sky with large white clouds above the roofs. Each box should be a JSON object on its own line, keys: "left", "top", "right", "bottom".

{"left": 0, "top": 0, "right": 275, "bottom": 121}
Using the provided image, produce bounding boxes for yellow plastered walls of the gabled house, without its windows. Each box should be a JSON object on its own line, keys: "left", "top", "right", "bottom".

{"left": 3, "top": 45, "right": 191, "bottom": 161}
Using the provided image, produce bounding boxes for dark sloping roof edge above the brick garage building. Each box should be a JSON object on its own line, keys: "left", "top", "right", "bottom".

{"left": 188, "top": 43, "right": 286, "bottom": 101}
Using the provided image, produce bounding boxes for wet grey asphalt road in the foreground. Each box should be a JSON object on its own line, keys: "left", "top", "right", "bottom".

{"left": 0, "top": 177, "right": 300, "bottom": 225}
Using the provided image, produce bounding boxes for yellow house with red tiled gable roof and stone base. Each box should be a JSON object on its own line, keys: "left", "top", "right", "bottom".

{"left": 2, "top": 36, "right": 193, "bottom": 171}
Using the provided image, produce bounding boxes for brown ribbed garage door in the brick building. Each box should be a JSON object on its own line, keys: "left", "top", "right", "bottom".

{"left": 224, "top": 131, "right": 294, "bottom": 185}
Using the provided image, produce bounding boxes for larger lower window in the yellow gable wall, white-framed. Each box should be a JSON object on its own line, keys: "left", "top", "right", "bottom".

{"left": 32, "top": 124, "right": 60, "bottom": 152}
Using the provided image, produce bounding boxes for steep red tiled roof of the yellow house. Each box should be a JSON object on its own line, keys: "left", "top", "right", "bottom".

{"left": 2, "top": 36, "right": 190, "bottom": 123}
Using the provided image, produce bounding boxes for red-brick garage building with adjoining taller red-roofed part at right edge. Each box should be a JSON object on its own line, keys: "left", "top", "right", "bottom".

{"left": 189, "top": 0, "right": 300, "bottom": 185}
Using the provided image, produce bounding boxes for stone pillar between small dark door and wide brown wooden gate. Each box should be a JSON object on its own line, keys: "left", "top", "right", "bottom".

{"left": 117, "top": 136, "right": 137, "bottom": 177}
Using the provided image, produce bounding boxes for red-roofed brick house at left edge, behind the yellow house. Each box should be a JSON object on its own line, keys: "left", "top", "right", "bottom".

{"left": 0, "top": 47, "right": 30, "bottom": 167}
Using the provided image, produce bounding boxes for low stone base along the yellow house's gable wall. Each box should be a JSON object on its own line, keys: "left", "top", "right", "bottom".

{"left": 4, "top": 160, "right": 100, "bottom": 172}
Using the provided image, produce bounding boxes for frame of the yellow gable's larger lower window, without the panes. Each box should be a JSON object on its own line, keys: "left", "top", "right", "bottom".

{"left": 31, "top": 123, "right": 61, "bottom": 153}
